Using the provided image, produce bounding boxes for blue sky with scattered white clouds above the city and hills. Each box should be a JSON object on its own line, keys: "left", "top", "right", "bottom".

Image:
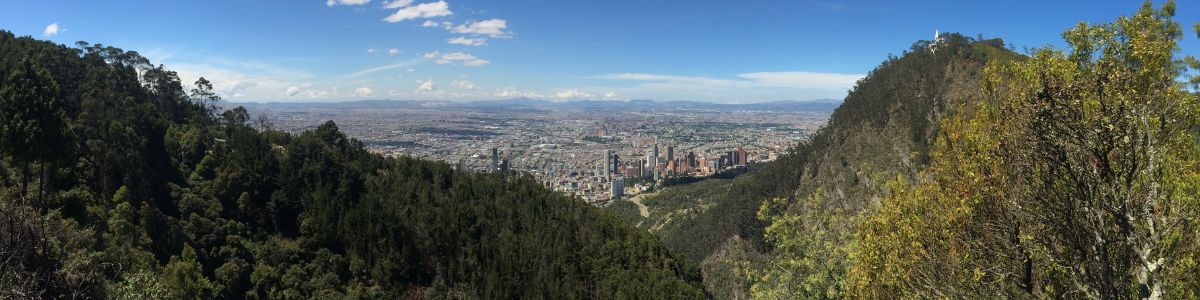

{"left": 0, "top": 0, "right": 1200, "bottom": 102}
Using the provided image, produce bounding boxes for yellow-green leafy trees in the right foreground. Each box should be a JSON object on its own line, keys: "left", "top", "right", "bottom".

{"left": 850, "top": 2, "right": 1200, "bottom": 299}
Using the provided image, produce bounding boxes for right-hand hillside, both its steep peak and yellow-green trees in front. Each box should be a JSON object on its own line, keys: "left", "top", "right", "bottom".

{"left": 749, "top": 1, "right": 1200, "bottom": 299}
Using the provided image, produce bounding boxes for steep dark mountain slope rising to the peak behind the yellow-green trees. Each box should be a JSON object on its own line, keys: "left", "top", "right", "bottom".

{"left": 617, "top": 34, "right": 1020, "bottom": 298}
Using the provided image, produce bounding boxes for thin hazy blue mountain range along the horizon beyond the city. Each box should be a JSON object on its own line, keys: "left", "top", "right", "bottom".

{"left": 226, "top": 98, "right": 841, "bottom": 113}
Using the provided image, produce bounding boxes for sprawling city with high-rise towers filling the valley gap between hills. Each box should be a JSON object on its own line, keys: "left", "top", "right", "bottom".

{"left": 246, "top": 100, "right": 836, "bottom": 203}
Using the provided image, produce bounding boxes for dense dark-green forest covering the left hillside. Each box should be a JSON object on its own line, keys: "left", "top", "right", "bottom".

{"left": 0, "top": 31, "right": 707, "bottom": 299}
